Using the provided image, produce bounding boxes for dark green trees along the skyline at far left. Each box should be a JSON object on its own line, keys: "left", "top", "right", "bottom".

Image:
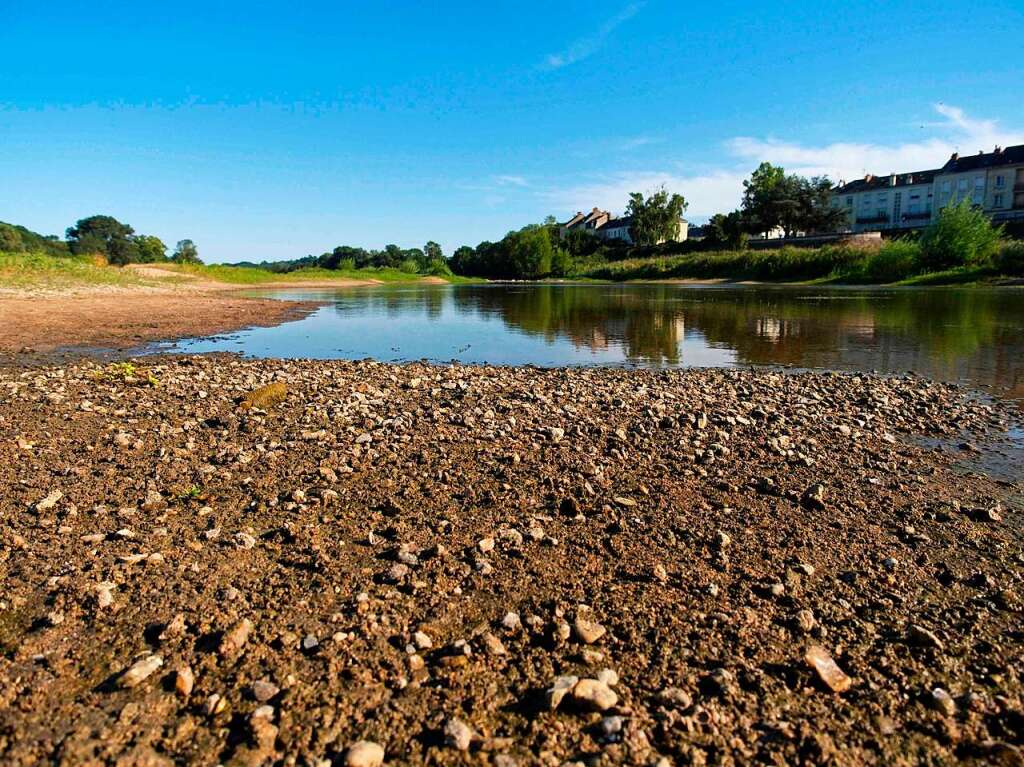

{"left": 0, "top": 215, "right": 202, "bottom": 266}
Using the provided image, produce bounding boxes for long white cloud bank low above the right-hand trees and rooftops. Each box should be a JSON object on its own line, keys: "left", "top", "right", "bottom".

{"left": 544, "top": 104, "right": 1024, "bottom": 220}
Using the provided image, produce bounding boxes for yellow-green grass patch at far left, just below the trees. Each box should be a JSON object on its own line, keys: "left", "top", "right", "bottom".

{"left": 0, "top": 253, "right": 148, "bottom": 289}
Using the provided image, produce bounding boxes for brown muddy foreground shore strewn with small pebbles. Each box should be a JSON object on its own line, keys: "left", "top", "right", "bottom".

{"left": 0, "top": 356, "right": 1024, "bottom": 765}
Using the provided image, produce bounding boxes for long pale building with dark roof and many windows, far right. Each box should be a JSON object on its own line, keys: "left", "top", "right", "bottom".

{"left": 833, "top": 144, "right": 1024, "bottom": 232}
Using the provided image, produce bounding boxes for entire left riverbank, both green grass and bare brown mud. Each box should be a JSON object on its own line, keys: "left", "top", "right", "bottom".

{"left": 0, "top": 256, "right": 454, "bottom": 356}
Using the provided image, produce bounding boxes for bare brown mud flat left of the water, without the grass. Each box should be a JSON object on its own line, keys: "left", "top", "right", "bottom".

{"left": 0, "top": 290, "right": 316, "bottom": 365}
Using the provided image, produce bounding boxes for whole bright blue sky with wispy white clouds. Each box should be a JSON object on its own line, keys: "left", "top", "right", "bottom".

{"left": 0, "top": 0, "right": 1024, "bottom": 261}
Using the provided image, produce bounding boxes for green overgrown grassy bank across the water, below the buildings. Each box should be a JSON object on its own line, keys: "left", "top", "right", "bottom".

{"left": 573, "top": 241, "right": 1024, "bottom": 285}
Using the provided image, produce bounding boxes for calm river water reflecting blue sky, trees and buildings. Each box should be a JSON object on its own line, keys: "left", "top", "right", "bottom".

{"left": 176, "top": 285, "right": 1024, "bottom": 397}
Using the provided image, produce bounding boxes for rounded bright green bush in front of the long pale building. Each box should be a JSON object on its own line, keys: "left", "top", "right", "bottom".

{"left": 921, "top": 200, "right": 1002, "bottom": 271}
